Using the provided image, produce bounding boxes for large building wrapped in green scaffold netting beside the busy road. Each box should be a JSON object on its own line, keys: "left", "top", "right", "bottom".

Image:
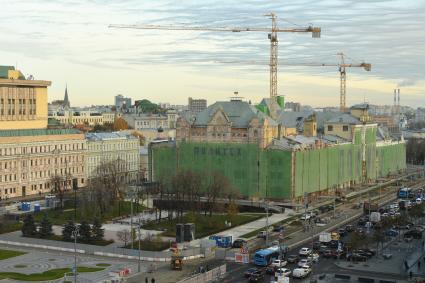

{"left": 149, "top": 99, "right": 406, "bottom": 202}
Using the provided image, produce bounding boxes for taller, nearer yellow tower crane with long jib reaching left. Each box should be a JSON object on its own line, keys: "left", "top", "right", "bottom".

{"left": 109, "top": 13, "right": 321, "bottom": 108}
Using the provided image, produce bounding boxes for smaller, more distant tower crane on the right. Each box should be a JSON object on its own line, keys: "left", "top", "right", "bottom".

{"left": 214, "top": 52, "right": 372, "bottom": 112}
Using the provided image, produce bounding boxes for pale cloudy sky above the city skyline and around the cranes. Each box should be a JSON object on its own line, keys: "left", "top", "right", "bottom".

{"left": 0, "top": 0, "right": 425, "bottom": 107}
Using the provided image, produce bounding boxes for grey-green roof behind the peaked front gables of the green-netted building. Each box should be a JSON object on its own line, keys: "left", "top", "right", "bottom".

{"left": 190, "top": 100, "right": 277, "bottom": 128}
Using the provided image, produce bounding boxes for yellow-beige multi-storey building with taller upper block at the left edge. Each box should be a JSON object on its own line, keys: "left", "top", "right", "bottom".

{"left": 0, "top": 66, "right": 86, "bottom": 199}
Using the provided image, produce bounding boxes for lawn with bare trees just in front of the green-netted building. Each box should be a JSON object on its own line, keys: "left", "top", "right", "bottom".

{"left": 143, "top": 213, "right": 263, "bottom": 238}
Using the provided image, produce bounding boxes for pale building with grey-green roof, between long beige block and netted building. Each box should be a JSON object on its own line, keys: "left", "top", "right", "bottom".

{"left": 86, "top": 132, "right": 140, "bottom": 182}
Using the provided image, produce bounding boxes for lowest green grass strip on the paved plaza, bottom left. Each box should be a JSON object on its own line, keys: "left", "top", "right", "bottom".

{"left": 0, "top": 267, "right": 105, "bottom": 281}
